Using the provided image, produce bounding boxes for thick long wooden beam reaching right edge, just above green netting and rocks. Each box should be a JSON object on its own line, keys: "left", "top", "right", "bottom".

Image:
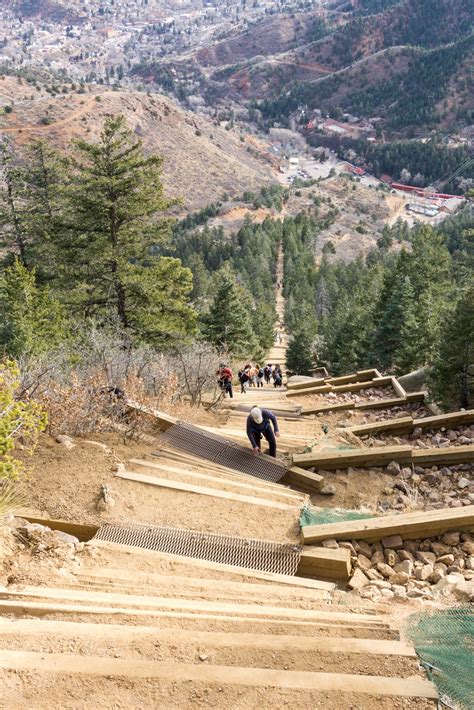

{"left": 301, "top": 505, "right": 474, "bottom": 545}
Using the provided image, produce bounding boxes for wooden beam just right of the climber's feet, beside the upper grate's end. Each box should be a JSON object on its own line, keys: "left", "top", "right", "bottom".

{"left": 293, "top": 446, "right": 412, "bottom": 470}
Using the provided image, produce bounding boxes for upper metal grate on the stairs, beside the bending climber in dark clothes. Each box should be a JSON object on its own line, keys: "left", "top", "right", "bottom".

{"left": 160, "top": 422, "right": 288, "bottom": 483}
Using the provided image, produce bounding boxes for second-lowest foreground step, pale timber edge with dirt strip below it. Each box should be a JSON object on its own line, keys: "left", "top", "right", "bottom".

{"left": 0, "top": 620, "right": 418, "bottom": 676}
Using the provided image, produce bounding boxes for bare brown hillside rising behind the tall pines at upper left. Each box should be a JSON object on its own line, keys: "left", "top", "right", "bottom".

{"left": 0, "top": 77, "right": 275, "bottom": 209}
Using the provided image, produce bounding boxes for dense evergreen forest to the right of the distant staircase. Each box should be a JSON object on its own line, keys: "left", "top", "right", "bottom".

{"left": 284, "top": 206, "right": 474, "bottom": 407}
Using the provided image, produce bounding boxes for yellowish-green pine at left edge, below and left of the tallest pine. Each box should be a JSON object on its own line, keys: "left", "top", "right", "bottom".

{"left": 0, "top": 258, "right": 68, "bottom": 357}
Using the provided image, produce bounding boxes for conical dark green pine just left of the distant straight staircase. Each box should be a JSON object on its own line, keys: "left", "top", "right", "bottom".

{"left": 202, "top": 265, "right": 258, "bottom": 358}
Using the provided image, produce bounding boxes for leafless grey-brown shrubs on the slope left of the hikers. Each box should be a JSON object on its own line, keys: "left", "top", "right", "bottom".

{"left": 20, "top": 328, "right": 222, "bottom": 436}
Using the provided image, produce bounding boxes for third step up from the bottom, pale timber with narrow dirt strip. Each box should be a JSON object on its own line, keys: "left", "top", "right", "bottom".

{"left": 0, "top": 601, "right": 399, "bottom": 641}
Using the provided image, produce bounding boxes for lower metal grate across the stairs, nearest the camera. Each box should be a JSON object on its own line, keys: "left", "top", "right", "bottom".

{"left": 94, "top": 524, "right": 303, "bottom": 576}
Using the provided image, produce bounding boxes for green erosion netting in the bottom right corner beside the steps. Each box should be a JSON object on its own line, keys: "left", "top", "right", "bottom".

{"left": 406, "top": 605, "right": 474, "bottom": 710}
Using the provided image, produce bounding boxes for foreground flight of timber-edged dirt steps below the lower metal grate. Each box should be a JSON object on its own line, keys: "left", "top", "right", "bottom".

{"left": 0, "top": 542, "right": 436, "bottom": 708}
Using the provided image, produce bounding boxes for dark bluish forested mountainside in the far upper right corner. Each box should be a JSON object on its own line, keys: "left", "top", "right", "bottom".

{"left": 149, "top": 0, "right": 474, "bottom": 138}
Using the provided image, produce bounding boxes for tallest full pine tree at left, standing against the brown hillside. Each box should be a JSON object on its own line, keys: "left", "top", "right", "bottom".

{"left": 50, "top": 116, "right": 194, "bottom": 343}
